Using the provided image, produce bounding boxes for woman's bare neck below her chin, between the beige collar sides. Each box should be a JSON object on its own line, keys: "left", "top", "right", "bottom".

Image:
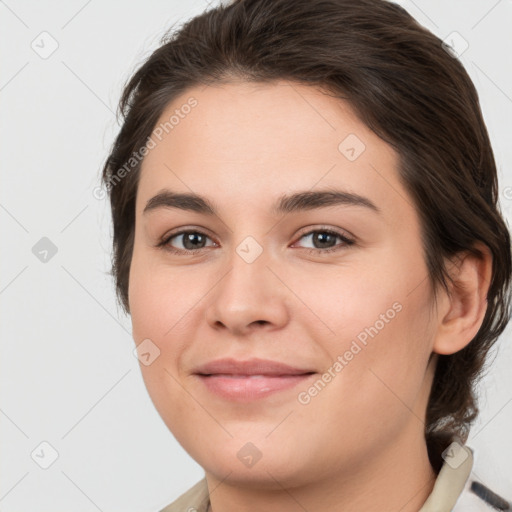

{"left": 206, "top": 432, "right": 437, "bottom": 512}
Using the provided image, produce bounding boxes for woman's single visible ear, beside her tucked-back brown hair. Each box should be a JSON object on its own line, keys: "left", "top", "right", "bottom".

{"left": 432, "top": 242, "right": 492, "bottom": 354}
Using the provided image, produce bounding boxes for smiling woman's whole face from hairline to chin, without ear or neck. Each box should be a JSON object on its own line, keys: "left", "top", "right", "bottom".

{"left": 129, "top": 81, "right": 436, "bottom": 487}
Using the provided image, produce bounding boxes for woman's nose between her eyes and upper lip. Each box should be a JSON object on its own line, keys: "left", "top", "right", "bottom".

{"left": 206, "top": 243, "right": 291, "bottom": 335}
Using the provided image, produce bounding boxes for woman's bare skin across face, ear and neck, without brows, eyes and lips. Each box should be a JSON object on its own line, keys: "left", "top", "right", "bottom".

{"left": 129, "top": 81, "right": 491, "bottom": 512}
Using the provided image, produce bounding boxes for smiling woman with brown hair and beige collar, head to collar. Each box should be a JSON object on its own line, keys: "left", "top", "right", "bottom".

{"left": 103, "top": 0, "right": 511, "bottom": 512}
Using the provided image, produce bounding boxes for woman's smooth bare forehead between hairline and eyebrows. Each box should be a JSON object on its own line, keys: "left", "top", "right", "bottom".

{"left": 137, "top": 81, "right": 406, "bottom": 220}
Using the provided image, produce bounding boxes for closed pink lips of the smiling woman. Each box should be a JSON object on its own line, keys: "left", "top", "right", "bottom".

{"left": 196, "top": 359, "right": 316, "bottom": 402}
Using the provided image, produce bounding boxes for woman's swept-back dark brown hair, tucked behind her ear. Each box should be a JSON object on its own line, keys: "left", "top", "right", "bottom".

{"left": 103, "top": 0, "right": 511, "bottom": 470}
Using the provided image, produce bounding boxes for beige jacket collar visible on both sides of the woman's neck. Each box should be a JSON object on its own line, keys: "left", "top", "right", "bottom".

{"left": 160, "top": 445, "right": 512, "bottom": 512}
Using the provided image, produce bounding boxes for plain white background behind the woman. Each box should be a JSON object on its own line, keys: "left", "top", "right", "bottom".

{"left": 0, "top": 0, "right": 512, "bottom": 512}
